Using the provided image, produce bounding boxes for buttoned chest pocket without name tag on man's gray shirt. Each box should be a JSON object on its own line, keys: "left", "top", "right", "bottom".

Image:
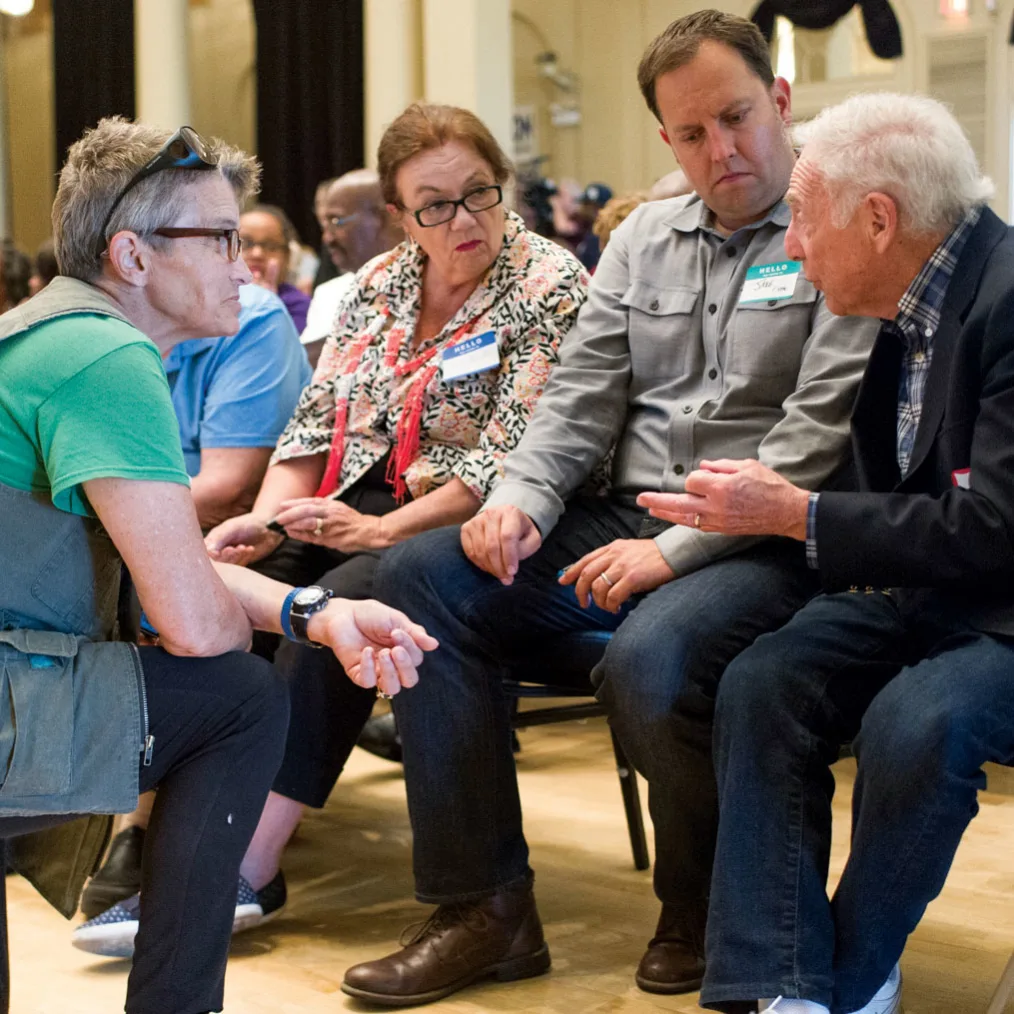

{"left": 621, "top": 279, "right": 701, "bottom": 377}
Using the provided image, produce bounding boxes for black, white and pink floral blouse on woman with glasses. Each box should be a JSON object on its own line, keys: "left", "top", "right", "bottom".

{"left": 272, "top": 212, "right": 588, "bottom": 500}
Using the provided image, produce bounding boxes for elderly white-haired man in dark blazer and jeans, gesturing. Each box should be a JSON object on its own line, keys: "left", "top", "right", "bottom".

{"left": 641, "top": 94, "right": 1014, "bottom": 1014}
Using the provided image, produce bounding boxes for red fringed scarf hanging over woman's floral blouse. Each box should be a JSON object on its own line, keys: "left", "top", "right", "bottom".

{"left": 314, "top": 306, "right": 487, "bottom": 503}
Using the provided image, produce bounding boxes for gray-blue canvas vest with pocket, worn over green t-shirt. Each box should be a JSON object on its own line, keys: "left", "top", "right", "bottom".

{"left": 0, "top": 278, "right": 148, "bottom": 915}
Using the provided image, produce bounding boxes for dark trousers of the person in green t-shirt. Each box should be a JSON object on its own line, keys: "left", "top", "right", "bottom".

{"left": 128, "top": 648, "right": 289, "bottom": 1014}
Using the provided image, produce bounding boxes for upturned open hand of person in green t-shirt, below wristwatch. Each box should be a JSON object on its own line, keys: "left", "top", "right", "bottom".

{"left": 306, "top": 598, "right": 439, "bottom": 697}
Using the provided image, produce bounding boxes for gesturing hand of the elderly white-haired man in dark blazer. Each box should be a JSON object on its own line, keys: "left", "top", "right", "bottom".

{"left": 637, "top": 459, "right": 810, "bottom": 539}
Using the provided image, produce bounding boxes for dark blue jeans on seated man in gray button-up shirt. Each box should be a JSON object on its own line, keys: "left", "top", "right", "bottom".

{"left": 374, "top": 499, "right": 812, "bottom": 903}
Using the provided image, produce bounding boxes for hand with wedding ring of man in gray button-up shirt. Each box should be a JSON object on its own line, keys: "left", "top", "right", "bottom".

{"left": 560, "top": 538, "right": 676, "bottom": 612}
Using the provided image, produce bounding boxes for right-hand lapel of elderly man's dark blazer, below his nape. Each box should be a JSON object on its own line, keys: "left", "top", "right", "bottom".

{"left": 909, "top": 208, "right": 1007, "bottom": 476}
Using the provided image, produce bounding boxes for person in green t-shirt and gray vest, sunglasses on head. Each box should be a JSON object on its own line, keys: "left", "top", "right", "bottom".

{"left": 0, "top": 118, "right": 435, "bottom": 1014}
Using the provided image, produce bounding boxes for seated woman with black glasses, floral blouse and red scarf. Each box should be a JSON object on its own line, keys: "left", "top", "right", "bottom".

{"left": 191, "top": 104, "right": 587, "bottom": 928}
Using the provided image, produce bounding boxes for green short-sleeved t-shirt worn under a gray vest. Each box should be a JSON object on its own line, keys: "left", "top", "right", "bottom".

{"left": 0, "top": 313, "right": 190, "bottom": 517}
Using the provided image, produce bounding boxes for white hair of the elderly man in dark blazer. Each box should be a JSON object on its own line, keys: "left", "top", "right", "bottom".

{"left": 796, "top": 92, "right": 993, "bottom": 234}
